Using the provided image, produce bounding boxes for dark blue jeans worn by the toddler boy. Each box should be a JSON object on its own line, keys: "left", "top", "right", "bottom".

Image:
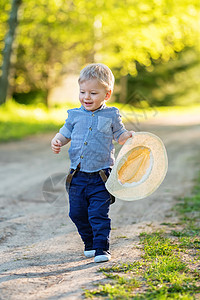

{"left": 69, "top": 169, "right": 111, "bottom": 250}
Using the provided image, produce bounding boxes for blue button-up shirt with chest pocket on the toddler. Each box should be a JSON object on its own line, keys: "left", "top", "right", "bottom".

{"left": 59, "top": 104, "right": 127, "bottom": 172}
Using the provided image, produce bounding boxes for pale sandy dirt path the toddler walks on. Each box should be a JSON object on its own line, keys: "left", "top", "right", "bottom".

{"left": 0, "top": 116, "right": 200, "bottom": 300}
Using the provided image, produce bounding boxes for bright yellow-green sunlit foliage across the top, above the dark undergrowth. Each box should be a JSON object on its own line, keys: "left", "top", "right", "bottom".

{"left": 0, "top": 0, "right": 200, "bottom": 101}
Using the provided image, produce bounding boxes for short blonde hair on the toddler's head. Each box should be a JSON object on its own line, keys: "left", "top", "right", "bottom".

{"left": 78, "top": 63, "right": 115, "bottom": 92}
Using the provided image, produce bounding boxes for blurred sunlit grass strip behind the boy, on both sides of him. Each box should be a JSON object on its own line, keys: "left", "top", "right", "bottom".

{"left": 0, "top": 100, "right": 200, "bottom": 142}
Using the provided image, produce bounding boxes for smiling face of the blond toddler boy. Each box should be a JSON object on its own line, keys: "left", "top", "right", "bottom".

{"left": 79, "top": 78, "right": 111, "bottom": 111}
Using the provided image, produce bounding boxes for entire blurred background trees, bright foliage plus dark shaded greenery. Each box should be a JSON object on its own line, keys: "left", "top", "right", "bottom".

{"left": 0, "top": 0, "right": 200, "bottom": 105}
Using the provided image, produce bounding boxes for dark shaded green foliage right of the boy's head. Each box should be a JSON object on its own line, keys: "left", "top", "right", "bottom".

{"left": 126, "top": 49, "right": 200, "bottom": 107}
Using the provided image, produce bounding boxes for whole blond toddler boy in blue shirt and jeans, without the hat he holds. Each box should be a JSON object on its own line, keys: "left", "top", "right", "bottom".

{"left": 51, "top": 63, "right": 133, "bottom": 262}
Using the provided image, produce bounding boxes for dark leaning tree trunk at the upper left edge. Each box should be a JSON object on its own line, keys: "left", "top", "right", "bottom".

{"left": 0, "top": 0, "right": 22, "bottom": 104}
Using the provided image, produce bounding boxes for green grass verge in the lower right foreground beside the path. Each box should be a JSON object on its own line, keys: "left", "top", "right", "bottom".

{"left": 85, "top": 174, "right": 200, "bottom": 300}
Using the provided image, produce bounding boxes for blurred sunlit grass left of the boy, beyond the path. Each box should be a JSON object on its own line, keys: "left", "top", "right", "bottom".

{"left": 0, "top": 101, "right": 73, "bottom": 142}
